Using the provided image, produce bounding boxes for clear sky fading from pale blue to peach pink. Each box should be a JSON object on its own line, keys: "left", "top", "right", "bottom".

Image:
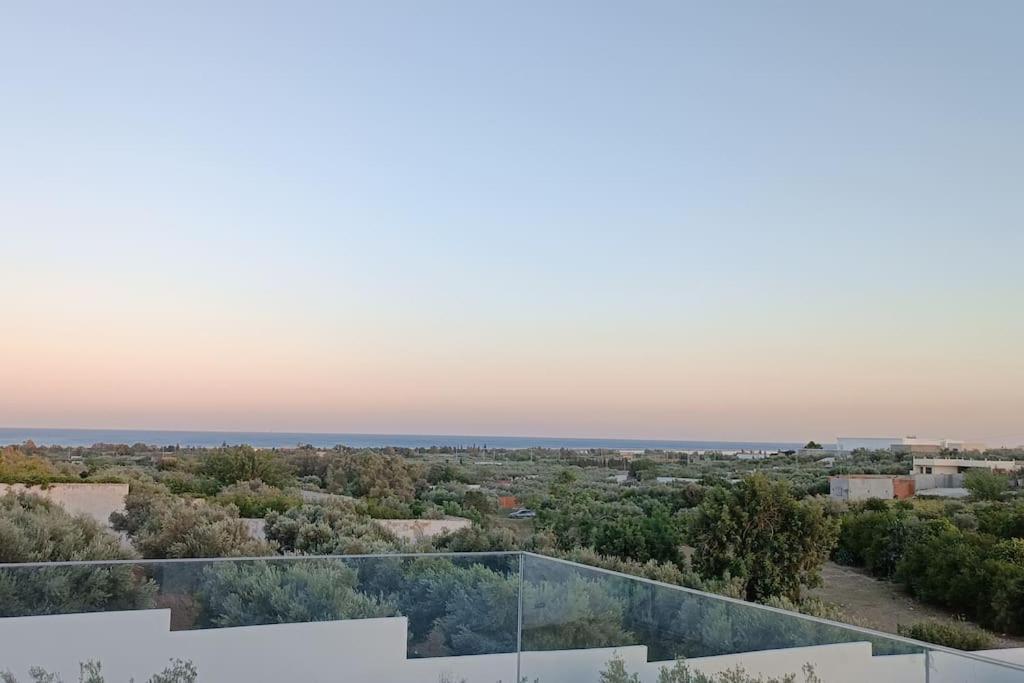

{"left": 0, "top": 0, "right": 1024, "bottom": 444}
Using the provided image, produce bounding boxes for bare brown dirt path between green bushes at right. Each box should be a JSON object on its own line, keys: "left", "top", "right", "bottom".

{"left": 810, "top": 562, "right": 1024, "bottom": 647}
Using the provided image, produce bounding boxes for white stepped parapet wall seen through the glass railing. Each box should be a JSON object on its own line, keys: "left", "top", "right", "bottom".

{"left": 0, "top": 609, "right": 983, "bottom": 683}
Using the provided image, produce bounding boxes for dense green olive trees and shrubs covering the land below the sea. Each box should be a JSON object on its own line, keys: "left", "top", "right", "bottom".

{"left": 0, "top": 444, "right": 1024, "bottom": 651}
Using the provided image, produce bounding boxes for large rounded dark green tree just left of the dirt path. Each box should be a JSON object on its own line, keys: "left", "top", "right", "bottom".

{"left": 690, "top": 475, "right": 839, "bottom": 601}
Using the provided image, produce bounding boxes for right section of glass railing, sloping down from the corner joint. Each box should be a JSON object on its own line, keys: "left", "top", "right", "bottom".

{"left": 520, "top": 555, "right": 1024, "bottom": 683}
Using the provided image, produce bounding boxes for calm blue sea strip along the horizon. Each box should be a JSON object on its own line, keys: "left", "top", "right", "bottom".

{"left": 0, "top": 427, "right": 800, "bottom": 451}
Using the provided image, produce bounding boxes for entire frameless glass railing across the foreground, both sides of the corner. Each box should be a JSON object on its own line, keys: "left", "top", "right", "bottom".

{"left": 0, "top": 553, "right": 1024, "bottom": 683}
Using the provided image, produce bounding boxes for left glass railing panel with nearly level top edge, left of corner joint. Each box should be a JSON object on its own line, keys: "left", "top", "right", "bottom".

{"left": 0, "top": 553, "right": 519, "bottom": 683}
